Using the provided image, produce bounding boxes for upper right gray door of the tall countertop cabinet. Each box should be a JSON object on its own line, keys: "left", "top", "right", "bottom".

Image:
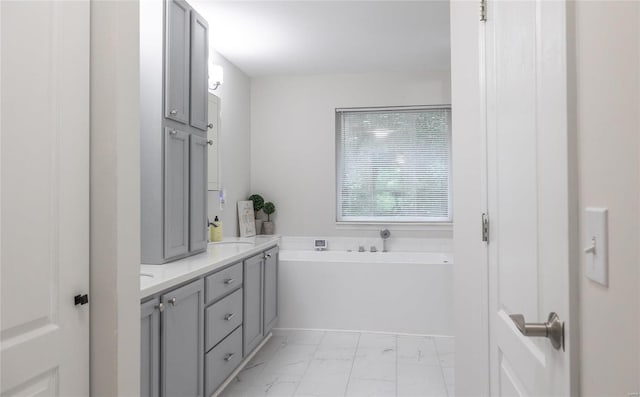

{"left": 189, "top": 10, "right": 209, "bottom": 131}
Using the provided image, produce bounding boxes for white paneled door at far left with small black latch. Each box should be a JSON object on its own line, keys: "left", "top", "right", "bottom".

{"left": 0, "top": 1, "right": 90, "bottom": 396}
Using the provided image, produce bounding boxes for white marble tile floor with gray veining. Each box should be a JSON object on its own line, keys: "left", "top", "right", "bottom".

{"left": 220, "top": 330, "right": 455, "bottom": 397}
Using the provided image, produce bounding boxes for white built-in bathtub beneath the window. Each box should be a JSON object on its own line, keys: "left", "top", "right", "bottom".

{"left": 277, "top": 250, "right": 453, "bottom": 336}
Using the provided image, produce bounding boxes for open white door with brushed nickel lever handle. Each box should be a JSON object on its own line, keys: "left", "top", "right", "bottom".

{"left": 485, "top": 0, "right": 573, "bottom": 396}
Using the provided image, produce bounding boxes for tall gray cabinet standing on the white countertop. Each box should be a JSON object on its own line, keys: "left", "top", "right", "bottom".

{"left": 140, "top": 0, "right": 209, "bottom": 264}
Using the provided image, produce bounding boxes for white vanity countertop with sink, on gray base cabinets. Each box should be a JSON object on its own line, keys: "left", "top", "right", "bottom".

{"left": 140, "top": 235, "right": 280, "bottom": 299}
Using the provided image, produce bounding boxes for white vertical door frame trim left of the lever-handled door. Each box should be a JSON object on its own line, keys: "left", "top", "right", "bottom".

{"left": 450, "top": 1, "right": 490, "bottom": 396}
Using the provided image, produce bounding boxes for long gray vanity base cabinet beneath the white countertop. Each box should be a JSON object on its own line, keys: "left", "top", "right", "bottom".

{"left": 140, "top": 246, "right": 278, "bottom": 397}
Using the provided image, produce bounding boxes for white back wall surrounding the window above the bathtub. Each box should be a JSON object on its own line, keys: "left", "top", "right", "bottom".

{"left": 251, "top": 73, "right": 451, "bottom": 237}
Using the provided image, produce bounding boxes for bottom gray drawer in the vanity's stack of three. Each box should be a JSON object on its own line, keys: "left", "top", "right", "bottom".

{"left": 204, "top": 327, "right": 242, "bottom": 396}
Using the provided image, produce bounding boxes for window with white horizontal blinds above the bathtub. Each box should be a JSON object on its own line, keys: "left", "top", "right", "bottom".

{"left": 336, "top": 106, "right": 452, "bottom": 222}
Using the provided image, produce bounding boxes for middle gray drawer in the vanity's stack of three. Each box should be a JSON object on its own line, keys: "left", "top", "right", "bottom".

{"left": 204, "top": 288, "right": 242, "bottom": 351}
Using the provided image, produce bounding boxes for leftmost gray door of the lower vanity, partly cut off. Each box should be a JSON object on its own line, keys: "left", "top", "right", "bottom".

{"left": 140, "top": 299, "right": 160, "bottom": 397}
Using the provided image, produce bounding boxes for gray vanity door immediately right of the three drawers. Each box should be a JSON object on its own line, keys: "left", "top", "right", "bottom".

{"left": 243, "top": 254, "right": 263, "bottom": 356}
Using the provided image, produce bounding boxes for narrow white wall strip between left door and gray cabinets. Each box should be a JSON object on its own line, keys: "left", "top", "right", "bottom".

{"left": 89, "top": 1, "right": 140, "bottom": 396}
